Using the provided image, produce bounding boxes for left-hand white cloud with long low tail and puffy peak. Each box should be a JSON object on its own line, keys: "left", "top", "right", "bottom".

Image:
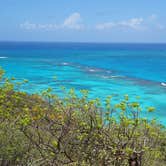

{"left": 20, "top": 13, "right": 83, "bottom": 31}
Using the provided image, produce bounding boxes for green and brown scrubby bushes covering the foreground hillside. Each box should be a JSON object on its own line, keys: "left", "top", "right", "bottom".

{"left": 0, "top": 68, "right": 166, "bottom": 166}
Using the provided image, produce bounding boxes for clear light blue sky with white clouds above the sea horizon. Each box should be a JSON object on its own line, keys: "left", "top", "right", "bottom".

{"left": 0, "top": 0, "right": 166, "bottom": 43}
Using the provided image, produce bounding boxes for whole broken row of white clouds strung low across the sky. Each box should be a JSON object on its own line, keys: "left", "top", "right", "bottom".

{"left": 20, "top": 12, "right": 165, "bottom": 31}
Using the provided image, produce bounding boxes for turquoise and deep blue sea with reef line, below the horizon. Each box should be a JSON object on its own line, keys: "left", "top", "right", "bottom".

{"left": 0, "top": 42, "right": 166, "bottom": 124}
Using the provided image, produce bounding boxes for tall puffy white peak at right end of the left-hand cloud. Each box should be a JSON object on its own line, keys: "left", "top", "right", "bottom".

{"left": 63, "top": 13, "right": 83, "bottom": 30}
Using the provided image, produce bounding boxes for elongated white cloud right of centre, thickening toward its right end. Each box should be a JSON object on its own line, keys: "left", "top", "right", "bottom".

{"left": 96, "top": 18, "right": 145, "bottom": 30}
